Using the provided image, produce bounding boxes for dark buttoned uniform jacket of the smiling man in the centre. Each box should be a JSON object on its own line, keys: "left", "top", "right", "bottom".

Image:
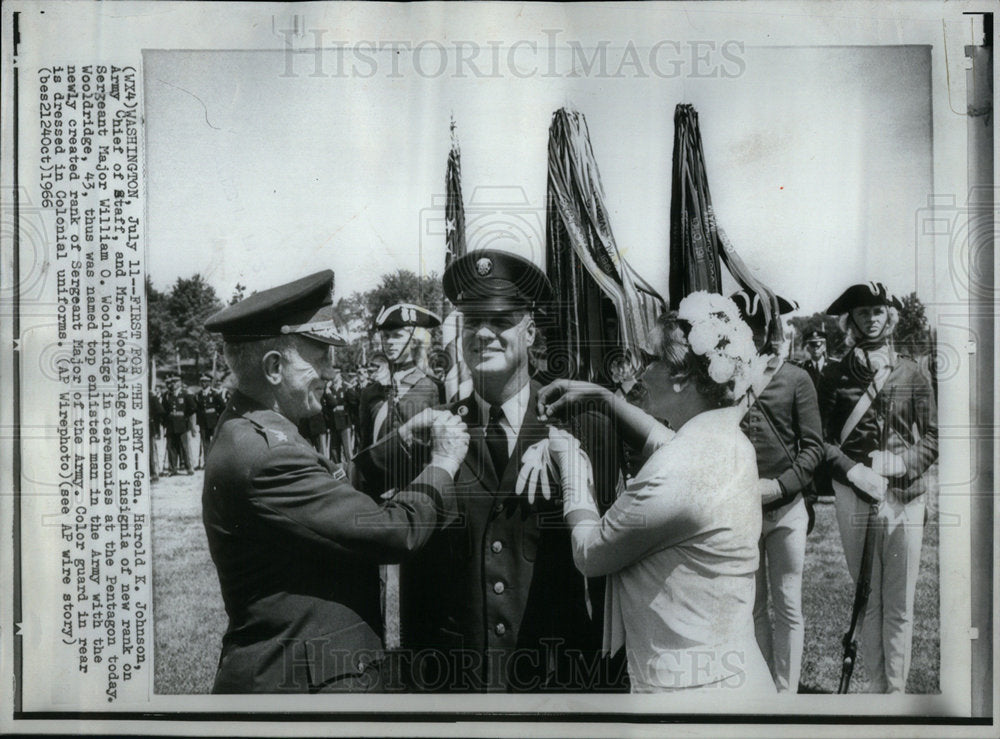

{"left": 357, "top": 382, "right": 626, "bottom": 692}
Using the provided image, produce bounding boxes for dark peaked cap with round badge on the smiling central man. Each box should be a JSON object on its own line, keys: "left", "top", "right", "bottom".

{"left": 442, "top": 249, "right": 552, "bottom": 313}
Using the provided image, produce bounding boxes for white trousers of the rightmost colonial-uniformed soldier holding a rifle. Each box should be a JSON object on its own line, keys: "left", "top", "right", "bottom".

{"left": 833, "top": 482, "right": 924, "bottom": 693}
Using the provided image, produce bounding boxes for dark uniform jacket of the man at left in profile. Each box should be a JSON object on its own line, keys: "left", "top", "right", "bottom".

{"left": 202, "top": 393, "right": 454, "bottom": 693}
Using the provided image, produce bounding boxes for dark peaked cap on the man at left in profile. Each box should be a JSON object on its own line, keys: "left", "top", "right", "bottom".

{"left": 205, "top": 269, "right": 347, "bottom": 346}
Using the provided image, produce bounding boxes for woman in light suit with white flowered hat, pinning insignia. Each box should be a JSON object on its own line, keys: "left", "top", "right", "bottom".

{"left": 539, "top": 292, "right": 774, "bottom": 694}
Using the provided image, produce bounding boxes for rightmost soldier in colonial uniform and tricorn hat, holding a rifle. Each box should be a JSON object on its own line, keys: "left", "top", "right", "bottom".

{"left": 820, "top": 282, "right": 938, "bottom": 693}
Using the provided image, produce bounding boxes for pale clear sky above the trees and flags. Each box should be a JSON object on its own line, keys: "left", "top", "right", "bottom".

{"left": 144, "top": 46, "right": 932, "bottom": 314}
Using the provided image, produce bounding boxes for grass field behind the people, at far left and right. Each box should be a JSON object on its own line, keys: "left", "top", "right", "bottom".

{"left": 153, "top": 472, "right": 940, "bottom": 694}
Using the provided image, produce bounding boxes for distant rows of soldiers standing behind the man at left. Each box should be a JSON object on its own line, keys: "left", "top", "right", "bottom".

{"left": 149, "top": 354, "right": 450, "bottom": 481}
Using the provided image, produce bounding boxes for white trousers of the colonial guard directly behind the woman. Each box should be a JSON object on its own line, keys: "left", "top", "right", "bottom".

{"left": 753, "top": 495, "right": 809, "bottom": 693}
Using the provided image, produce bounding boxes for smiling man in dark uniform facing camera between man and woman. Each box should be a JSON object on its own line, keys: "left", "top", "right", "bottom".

{"left": 357, "top": 249, "right": 623, "bottom": 692}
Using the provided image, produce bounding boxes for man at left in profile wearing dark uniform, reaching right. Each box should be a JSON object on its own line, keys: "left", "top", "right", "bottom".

{"left": 202, "top": 270, "right": 468, "bottom": 693}
